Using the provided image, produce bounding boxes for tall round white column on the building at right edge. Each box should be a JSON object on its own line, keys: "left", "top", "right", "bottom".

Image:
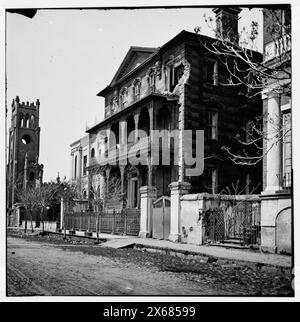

{"left": 265, "top": 93, "right": 282, "bottom": 192}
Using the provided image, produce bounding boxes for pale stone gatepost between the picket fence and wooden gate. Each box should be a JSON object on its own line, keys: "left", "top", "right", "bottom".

{"left": 139, "top": 186, "right": 156, "bottom": 238}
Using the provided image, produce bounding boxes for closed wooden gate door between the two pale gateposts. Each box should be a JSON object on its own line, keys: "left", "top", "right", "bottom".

{"left": 152, "top": 196, "right": 170, "bottom": 239}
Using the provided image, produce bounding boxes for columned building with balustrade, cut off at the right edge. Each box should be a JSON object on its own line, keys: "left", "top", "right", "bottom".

{"left": 261, "top": 5, "right": 292, "bottom": 253}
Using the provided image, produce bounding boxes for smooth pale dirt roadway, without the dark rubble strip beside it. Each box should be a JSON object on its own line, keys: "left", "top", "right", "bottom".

{"left": 7, "top": 237, "right": 216, "bottom": 296}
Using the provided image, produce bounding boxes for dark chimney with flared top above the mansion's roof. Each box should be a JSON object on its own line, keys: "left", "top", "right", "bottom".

{"left": 213, "top": 7, "right": 242, "bottom": 44}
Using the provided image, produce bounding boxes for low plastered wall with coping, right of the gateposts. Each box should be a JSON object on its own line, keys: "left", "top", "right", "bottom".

{"left": 180, "top": 193, "right": 260, "bottom": 245}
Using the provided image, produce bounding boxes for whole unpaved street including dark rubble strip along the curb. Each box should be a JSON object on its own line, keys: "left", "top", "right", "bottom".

{"left": 7, "top": 237, "right": 291, "bottom": 296}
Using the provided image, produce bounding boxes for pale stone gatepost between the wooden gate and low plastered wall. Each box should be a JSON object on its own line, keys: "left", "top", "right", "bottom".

{"left": 169, "top": 181, "right": 191, "bottom": 242}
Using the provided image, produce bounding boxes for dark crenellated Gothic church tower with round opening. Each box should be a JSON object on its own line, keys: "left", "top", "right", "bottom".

{"left": 7, "top": 96, "right": 43, "bottom": 208}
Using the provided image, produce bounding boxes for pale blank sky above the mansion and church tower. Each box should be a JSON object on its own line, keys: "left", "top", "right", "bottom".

{"left": 6, "top": 8, "right": 262, "bottom": 181}
